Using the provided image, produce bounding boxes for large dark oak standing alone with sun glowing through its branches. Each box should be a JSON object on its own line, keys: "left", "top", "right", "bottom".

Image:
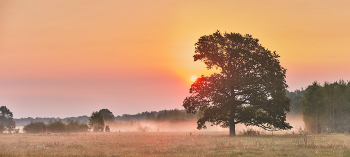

{"left": 183, "top": 31, "right": 292, "bottom": 136}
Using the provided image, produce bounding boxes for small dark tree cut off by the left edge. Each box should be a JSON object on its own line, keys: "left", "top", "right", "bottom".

{"left": 0, "top": 106, "right": 16, "bottom": 133}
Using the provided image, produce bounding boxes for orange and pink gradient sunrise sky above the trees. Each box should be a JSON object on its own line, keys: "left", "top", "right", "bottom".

{"left": 0, "top": 0, "right": 350, "bottom": 118}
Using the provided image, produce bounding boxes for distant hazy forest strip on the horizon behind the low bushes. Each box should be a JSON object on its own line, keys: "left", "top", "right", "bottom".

{"left": 14, "top": 109, "right": 202, "bottom": 126}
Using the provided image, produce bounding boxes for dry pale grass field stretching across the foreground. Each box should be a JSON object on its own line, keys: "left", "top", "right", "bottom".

{"left": 0, "top": 132, "right": 350, "bottom": 156}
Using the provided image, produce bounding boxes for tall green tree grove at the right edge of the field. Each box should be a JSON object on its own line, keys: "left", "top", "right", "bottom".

{"left": 302, "top": 80, "right": 350, "bottom": 133}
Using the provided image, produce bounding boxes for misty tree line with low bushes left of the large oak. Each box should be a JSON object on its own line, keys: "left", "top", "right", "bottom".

{"left": 10, "top": 109, "right": 203, "bottom": 133}
